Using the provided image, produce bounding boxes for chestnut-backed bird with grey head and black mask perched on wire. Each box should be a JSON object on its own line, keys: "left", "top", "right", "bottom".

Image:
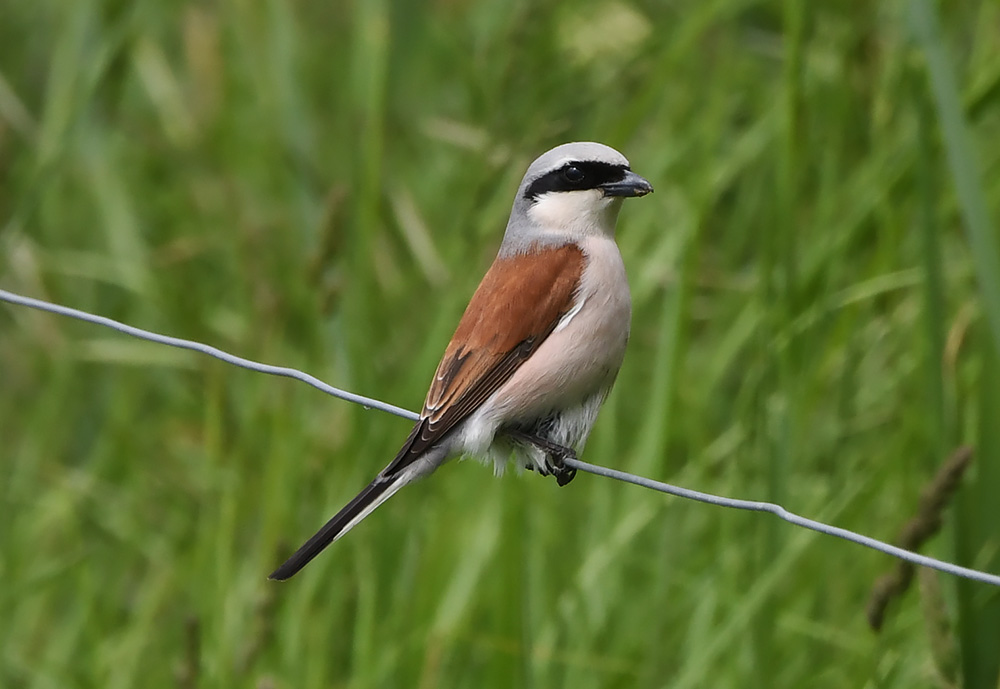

{"left": 269, "top": 142, "right": 653, "bottom": 581}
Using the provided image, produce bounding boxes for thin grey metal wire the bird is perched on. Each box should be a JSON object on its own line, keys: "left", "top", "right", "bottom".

{"left": 0, "top": 290, "right": 1000, "bottom": 586}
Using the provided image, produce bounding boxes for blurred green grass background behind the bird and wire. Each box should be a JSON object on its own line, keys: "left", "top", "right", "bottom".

{"left": 0, "top": 0, "right": 1000, "bottom": 689}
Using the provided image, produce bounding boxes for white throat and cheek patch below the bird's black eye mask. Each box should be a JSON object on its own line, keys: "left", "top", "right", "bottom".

{"left": 528, "top": 189, "right": 622, "bottom": 238}
